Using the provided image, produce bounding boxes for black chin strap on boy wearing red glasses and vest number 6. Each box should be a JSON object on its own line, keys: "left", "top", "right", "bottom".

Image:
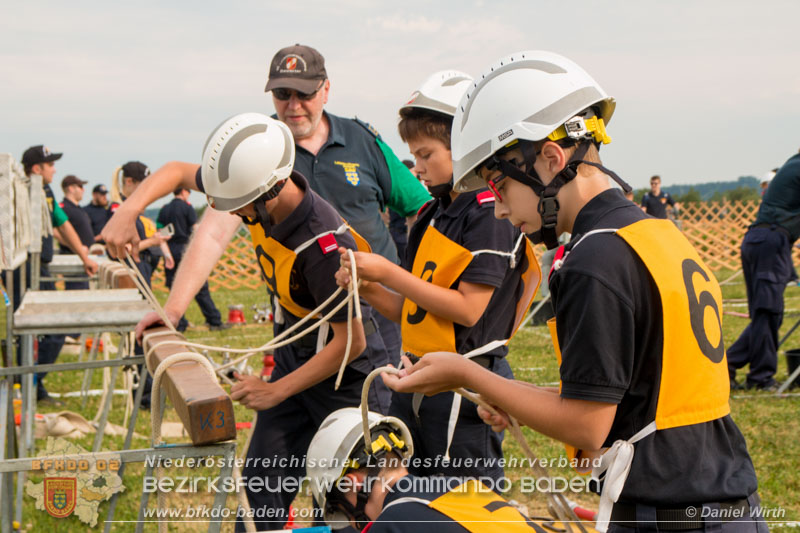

{"left": 490, "top": 141, "right": 632, "bottom": 250}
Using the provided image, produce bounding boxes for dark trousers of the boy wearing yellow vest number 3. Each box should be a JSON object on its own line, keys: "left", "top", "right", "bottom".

{"left": 389, "top": 356, "right": 514, "bottom": 480}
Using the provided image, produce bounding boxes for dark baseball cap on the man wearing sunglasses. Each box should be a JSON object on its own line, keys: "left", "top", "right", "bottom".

{"left": 264, "top": 44, "right": 328, "bottom": 93}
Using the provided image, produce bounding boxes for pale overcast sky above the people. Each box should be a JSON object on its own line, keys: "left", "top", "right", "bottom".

{"left": 0, "top": 0, "right": 800, "bottom": 203}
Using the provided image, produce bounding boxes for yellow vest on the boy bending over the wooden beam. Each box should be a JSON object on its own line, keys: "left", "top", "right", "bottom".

{"left": 248, "top": 223, "right": 371, "bottom": 318}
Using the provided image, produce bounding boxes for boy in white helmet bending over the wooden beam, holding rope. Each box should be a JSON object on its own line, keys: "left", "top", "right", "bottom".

{"left": 104, "top": 113, "right": 389, "bottom": 531}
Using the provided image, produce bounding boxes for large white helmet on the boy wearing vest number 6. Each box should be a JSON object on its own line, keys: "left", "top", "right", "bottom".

{"left": 451, "top": 50, "right": 616, "bottom": 192}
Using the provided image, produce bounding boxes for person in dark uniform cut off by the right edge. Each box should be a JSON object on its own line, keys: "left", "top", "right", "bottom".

{"left": 728, "top": 154, "right": 800, "bottom": 390}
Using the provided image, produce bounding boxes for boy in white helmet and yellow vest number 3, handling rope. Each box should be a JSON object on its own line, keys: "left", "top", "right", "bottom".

{"left": 339, "top": 71, "right": 540, "bottom": 479}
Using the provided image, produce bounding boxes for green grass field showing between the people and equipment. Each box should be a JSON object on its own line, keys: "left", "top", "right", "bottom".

{"left": 2, "top": 272, "right": 800, "bottom": 532}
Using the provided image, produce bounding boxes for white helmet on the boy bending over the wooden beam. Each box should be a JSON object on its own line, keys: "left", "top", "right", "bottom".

{"left": 200, "top": 113, "right": 294, "bottom": 211}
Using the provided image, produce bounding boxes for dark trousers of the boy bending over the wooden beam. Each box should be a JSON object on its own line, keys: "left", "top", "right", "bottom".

{"left": 236, "top": 322, "right": 391, "bottom": 532}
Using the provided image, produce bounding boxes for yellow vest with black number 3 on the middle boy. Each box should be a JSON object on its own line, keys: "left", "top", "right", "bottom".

{"left": 400, "top": 224, "right": 542, "bottom": 357}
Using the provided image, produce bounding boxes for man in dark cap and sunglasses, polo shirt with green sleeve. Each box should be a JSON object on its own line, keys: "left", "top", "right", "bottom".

{"left": 103, "top": 44, "right": 431, "bottom": 362}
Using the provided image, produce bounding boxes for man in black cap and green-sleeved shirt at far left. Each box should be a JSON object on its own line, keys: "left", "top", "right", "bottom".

{"left": 14, "top": 144, "right": 97, "bottom": 403}
